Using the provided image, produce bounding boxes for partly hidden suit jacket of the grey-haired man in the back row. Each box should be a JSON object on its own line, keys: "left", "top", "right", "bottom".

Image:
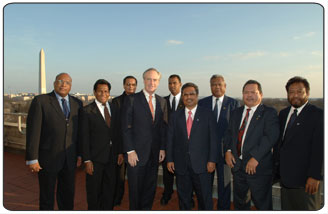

{"left": 198, "top": 95, "right": 240, "bottom": 162}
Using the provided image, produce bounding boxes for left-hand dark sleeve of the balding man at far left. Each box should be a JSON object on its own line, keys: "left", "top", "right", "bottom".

{"left": 26, "top": 97, "right": 42, "bottom": 160}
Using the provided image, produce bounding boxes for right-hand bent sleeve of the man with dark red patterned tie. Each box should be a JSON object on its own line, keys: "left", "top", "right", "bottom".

{"left": 250, "top": 108, "right": 279, "bottom": 162}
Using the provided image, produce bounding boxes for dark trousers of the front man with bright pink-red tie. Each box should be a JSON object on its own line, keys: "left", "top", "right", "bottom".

{"left": 176, "top": 161, "right": 213, "bottom": 210}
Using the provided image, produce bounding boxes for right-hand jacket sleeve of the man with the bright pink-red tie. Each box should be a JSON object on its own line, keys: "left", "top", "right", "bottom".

{"left": 208, "top": 111, "right": 222, "bottom": 163}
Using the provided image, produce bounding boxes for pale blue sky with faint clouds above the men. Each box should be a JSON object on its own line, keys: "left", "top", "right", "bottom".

{"left": 3, "top": 4, "right": 324, "bottom": 98}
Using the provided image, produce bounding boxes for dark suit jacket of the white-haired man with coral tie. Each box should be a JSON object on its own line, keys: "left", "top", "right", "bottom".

{"left": 122, "top": 91, "right": 167, "bottom": 166}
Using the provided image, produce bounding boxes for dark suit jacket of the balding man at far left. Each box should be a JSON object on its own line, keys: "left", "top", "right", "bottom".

{"left": 26, "top": 91, "right": 82, "bottom": 172}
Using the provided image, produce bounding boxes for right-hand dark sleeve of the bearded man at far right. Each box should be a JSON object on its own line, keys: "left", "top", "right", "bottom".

{"left": 308, "top": 110, "right": 324, "bottom": 180}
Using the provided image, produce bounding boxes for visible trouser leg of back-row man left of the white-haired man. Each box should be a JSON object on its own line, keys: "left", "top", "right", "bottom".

{"left": 114, "top": 161, "right": 126, "bottom": 204}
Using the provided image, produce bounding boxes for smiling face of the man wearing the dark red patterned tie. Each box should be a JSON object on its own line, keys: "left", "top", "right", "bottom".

{"left": 243, "top": 84, "right": 262, "bottom": 107}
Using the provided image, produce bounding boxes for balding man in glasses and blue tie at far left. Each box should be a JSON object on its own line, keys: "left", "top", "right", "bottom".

{"left": 26, "top": 73, "right": 82, "bottom": 210}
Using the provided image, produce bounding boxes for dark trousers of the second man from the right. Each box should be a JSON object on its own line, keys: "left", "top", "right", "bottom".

{"left": 233, "top": 167, "right": 272, "bottom": 210}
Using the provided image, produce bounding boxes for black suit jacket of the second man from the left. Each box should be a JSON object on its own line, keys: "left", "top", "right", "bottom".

{"left": 81, "top": 101, "right": 122, "bottom": 164}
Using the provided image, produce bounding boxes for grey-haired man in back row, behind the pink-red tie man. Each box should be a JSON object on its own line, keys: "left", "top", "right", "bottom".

{"left": 198, "top": 75, "right": 239, "bottom": 210}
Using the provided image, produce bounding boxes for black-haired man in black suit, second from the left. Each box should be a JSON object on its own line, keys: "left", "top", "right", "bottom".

{"left": 81, "top": 79, "right": 123, "bottom": 210}
